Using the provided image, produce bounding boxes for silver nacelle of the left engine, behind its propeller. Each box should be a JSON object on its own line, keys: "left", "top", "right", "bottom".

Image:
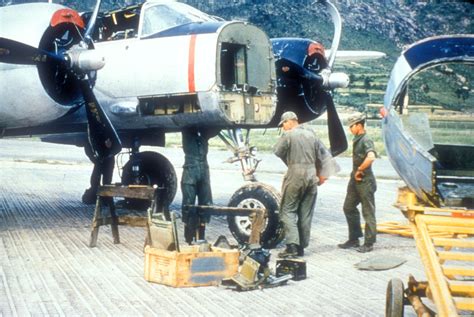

{"left": 0, "top": 3, "right": 82, "bottom": 128}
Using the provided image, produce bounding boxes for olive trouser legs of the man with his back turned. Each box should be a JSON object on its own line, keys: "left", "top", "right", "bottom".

{"left": 279, "top": 165, "right": 318, "bottom": 248}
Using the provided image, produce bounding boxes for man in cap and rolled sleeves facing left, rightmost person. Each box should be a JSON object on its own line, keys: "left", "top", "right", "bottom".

{"left": 338, "top": 114, "right": 377, "bottom": 253}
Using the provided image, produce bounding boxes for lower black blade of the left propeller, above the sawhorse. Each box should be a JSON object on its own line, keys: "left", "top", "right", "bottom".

{"left": 80, "top": 78, "right": 122, "bottom": 161}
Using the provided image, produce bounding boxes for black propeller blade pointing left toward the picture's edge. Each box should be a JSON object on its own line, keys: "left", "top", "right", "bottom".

{"left": 0, "top": 37, "right": 66, "bottom": 65}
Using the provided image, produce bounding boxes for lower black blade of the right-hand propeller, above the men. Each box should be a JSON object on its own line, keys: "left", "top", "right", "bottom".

{"left": 326, "top": 93, "right": 347, "bottom": 156}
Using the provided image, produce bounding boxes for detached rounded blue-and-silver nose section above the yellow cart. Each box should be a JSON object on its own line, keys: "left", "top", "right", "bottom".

{"left": 382, "top": 34, "right": 474, "bottom": 209}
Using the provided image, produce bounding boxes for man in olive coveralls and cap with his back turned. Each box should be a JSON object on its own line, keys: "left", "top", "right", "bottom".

{"left": 274, "top": 111, "right": 337, "bottom": 258}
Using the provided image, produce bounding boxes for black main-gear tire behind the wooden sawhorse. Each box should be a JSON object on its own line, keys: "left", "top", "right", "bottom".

{"left": 122, "top": 152, "right": 178, "bottom": 209}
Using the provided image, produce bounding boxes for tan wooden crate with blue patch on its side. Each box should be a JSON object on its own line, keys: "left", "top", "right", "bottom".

{"left": 145, "top": 245, "right": 239, "bottom": 287}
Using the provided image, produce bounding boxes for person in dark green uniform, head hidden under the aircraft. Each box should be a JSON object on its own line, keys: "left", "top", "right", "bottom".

{"left": 181, "top": 129, "right": 217, "bottom": 244}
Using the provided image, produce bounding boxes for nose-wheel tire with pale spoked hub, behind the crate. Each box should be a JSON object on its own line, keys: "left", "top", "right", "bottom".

{"left": 227, "top": 183, "right": 284, "bottom": 249}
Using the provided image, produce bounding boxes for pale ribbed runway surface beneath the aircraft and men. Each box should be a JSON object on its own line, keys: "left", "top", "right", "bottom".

{"left": 0, "top": 140, "right": 426, "bottom": 316}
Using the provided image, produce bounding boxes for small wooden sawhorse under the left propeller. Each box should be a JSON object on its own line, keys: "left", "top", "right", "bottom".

{"left": 89, "top": 185, "right": 163, "bottom": 248}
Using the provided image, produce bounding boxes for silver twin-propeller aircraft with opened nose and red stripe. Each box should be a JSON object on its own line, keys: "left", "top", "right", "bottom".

{"left": 0, "top": 1, "right": 381, "bottom": 245}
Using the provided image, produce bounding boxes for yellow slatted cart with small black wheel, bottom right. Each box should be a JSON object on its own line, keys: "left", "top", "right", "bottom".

{"left": 385, "top": 192, "right": 474, "bottom": 317}
